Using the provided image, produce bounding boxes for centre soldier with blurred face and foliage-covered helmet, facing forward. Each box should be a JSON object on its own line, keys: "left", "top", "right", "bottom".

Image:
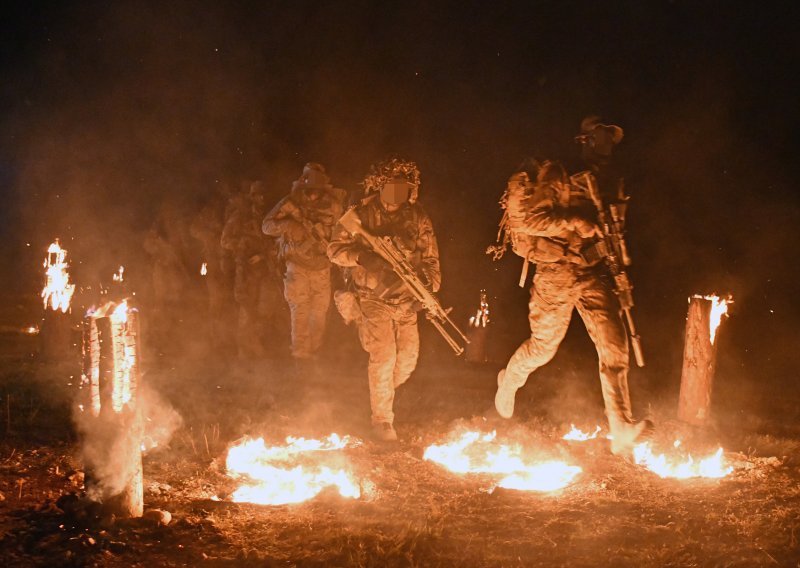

{"left": 328, "top": 159, "right": 441, "bottom": 441}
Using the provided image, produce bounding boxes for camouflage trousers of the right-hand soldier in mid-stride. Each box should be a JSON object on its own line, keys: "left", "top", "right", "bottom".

{"left": 503, "top": 263, "right": 632, "bottom": 427}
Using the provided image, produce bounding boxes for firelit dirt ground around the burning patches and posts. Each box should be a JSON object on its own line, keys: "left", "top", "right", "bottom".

{"left": 0, "top": 300, "right": 800, "bottom": 567}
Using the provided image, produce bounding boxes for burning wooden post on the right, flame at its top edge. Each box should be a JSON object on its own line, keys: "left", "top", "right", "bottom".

{"left": 678, "top": 295, "right": 731, "bottom": 426}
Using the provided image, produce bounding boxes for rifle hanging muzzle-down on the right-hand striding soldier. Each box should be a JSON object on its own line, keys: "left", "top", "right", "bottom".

{"left": 579, "top": 172, "right": 644, "bottom": 367}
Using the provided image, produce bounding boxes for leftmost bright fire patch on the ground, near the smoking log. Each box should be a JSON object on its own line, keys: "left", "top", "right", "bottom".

{"left": 225, "top": 434, "right": 361, "bottom": 505}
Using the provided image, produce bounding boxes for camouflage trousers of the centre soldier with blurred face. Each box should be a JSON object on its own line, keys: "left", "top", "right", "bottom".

{"left": 359, "top": 298, "right": 419, "bottom": 424}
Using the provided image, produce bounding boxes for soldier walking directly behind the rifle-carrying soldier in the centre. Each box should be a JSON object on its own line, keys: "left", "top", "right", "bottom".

{"left": 262, "top": 163, "right": 345, "bottom": 361}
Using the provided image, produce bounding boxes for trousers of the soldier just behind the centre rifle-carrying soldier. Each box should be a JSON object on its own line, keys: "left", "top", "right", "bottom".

{"left": 283, "top": 262, "right": 331, "bottom": 359}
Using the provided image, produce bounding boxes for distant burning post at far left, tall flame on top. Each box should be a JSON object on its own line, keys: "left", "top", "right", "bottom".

{"left": 40, "top": 239, "right": 75, "bottom": 360}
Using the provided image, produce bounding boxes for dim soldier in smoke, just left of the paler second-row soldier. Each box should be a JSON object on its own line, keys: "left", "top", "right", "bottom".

{"left": 220, "top": 181, "right": 279, "bottom": 360}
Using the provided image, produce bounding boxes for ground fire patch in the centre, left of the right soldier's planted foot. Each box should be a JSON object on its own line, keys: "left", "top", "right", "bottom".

{"left": 423, "top": 431, "right": 582, "bottom": 491}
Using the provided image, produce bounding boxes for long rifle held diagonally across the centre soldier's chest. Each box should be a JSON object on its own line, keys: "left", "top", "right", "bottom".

{"left": 339, "top": 208, "right": 469, "bottom": 355}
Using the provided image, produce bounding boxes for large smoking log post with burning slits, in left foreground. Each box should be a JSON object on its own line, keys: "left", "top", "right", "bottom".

{"left": 81, "top": 301, "right": 144, "bottom": 518}
